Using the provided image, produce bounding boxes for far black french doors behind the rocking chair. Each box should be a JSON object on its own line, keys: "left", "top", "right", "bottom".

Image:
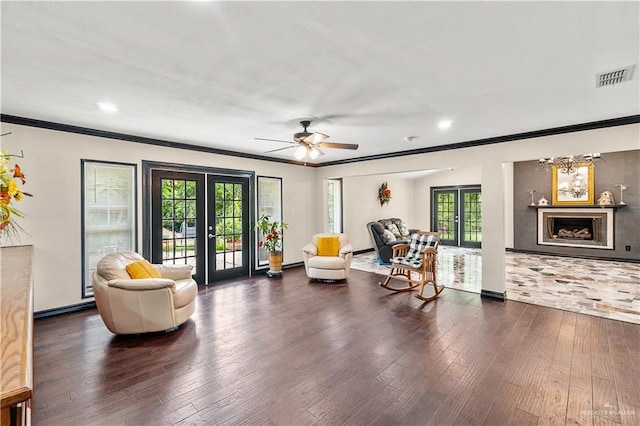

{"left": 431, "top": 186, "right": 482, "bottom": 247}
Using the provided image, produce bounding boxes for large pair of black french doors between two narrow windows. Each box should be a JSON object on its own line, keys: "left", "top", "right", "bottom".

{"left": 149, "top": 170, "right": 250, "bottom": 284}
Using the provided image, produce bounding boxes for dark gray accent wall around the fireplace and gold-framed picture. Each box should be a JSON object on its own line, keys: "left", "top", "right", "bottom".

{"left": 513, "top": 150, "right": 640, "bottom": 261}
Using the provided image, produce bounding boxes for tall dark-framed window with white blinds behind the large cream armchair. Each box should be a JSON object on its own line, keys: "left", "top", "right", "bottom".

{"left": 82, "top": 160, "right": 136, "bottom": 297}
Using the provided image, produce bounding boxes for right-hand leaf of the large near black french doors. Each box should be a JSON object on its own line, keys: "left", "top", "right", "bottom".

{"left": 207, "top": 175, "right": 249, "bottom": 283}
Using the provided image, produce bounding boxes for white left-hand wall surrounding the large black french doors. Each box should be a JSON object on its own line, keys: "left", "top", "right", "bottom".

{"left": 2, "top": 123, "right": 320, "bottom": 311}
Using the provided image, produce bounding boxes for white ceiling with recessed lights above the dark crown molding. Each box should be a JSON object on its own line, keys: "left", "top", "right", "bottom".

{"left": 1, "top": 1, "right": 640, "bottom": 163}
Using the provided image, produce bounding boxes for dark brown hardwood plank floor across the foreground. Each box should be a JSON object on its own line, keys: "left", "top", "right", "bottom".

{"left": 33, "top": 268, "right": 640, "bottom": 425}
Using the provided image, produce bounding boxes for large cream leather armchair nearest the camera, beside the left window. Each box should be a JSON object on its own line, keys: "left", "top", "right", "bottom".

{"left": 93, "top": 252, "right": 198, "bottom": 334}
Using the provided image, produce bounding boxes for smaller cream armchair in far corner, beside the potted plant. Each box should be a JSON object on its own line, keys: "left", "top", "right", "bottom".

{"left": 302, "top": 234, "right": 353, "bottom": 281}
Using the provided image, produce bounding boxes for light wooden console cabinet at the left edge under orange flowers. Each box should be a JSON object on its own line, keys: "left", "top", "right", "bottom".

{"left": 0, "top": 246, "right": 33, "bottom": 426}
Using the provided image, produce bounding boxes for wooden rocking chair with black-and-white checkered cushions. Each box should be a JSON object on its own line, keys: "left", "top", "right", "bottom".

{"left": 380, "top": 231, "right": 444, "bottom": 302}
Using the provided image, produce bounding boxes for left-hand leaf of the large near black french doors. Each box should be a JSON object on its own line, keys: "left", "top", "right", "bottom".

{"left": 151, "top": 170, "right": 206, "bottom": 284}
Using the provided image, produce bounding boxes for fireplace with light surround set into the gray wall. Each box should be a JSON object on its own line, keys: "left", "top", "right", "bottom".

{"left": 538, "top": 207, "right": 613, "bottom": 250}
